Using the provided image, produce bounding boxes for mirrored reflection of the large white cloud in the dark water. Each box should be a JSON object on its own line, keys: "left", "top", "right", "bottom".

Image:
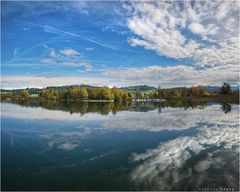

{"left": 130, "top": 126, "right": 239, "bottom": 190}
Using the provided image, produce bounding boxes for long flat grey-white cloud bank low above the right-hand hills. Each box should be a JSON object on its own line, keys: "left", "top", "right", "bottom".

{"left": 103, "top": 64, "right": 239, "bottom": 87}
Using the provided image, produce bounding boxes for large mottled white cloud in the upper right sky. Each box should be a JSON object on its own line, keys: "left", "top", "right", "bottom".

{"left": 127, "top": 1, "right": 239, "bottom": 66}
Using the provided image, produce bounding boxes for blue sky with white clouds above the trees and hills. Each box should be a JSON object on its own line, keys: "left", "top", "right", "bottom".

{"left": 1, "top": 1, "right": 240, "bottom": 89}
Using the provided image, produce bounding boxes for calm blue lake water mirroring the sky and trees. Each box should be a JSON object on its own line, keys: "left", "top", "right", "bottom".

{"left": 1, "top": 101, "right": 239, "bottom": 190}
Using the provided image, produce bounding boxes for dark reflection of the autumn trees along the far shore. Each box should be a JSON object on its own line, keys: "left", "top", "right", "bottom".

{"left": 3, "top": 100, "right": 208, "bottom": 116}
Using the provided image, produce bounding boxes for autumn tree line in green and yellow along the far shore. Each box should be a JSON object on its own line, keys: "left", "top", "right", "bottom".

{"left": 1, "top": 82, "right": 236, "bottom": 101}
